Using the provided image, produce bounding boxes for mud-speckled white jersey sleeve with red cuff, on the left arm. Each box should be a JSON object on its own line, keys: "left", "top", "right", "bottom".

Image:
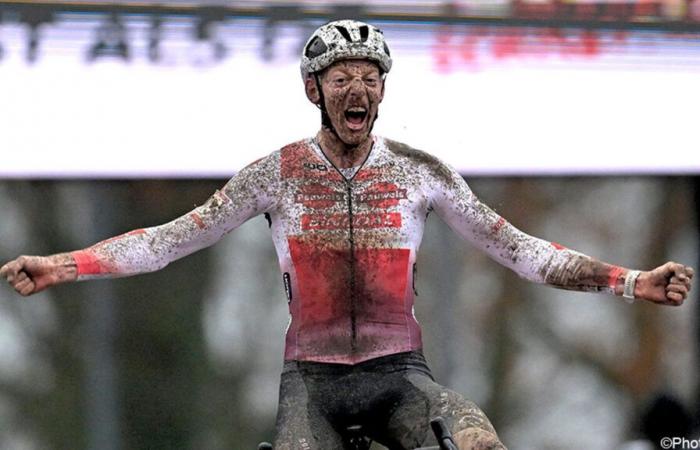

{"left": 71, "top": 153, "right": 279, "bottom": 280}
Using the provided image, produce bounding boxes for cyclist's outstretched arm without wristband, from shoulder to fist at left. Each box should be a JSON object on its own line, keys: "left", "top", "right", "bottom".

{"left": 0, "top": 153, "right": 276, "bottom": 296}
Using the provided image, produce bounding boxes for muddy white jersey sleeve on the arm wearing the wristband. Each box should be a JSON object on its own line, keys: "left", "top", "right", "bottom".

{"left": 430, "top": 159, "right": 626, "bottom": 293}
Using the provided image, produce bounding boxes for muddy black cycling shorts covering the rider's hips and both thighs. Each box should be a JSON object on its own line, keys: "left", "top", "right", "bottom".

{"left": 274, "top": 351, "right": 496, "bottom": 450}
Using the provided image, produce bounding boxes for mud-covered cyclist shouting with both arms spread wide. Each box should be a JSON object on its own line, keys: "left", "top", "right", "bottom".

{"left": 0, "top": 20, "right": 693, "bottom": 449}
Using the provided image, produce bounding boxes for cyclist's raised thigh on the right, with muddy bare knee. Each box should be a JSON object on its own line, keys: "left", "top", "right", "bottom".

{"left": 384, "top": 372, "right": 496, "bottom": 449}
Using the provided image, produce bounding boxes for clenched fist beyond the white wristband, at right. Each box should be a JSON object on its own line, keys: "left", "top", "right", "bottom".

{"left": 634, "top": 262, "right": 695, "bottom": 306}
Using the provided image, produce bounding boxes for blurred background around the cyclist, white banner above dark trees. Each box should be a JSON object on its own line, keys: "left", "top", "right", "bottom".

{"left": 0, "top": 0, "right": 700, "bottom": 450}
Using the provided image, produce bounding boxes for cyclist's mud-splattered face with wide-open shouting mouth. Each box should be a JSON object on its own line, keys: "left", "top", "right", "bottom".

{"left": 306, "top": 60, "right": 384, "bottom": 145}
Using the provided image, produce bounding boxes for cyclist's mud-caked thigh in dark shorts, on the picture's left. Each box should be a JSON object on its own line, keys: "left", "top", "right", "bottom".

{"left": 274, "top": 367, "right": 343, "bottom": 450}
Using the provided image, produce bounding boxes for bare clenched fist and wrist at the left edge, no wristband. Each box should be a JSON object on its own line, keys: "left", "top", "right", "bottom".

{"left": 0, "top": 253, "right": 78, "bottom": 297}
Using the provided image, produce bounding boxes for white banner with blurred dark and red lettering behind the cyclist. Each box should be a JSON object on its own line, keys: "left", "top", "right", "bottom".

{"left": 0, "top": 20, "right": 700, "bottom": 178}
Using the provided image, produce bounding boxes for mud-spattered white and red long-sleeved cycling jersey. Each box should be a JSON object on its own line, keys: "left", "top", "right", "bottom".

{"left": 73, "top": 136, "right": 622, "bottom": 364}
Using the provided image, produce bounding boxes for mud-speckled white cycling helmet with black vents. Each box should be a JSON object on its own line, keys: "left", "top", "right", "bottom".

{"left": 301, "top": 20, "right": 391, "bottom": 79}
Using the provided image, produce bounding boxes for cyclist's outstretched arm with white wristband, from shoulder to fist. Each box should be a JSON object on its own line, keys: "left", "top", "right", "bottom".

{"left": 431, "top": 158, "right": 694, "bottom": 305}
